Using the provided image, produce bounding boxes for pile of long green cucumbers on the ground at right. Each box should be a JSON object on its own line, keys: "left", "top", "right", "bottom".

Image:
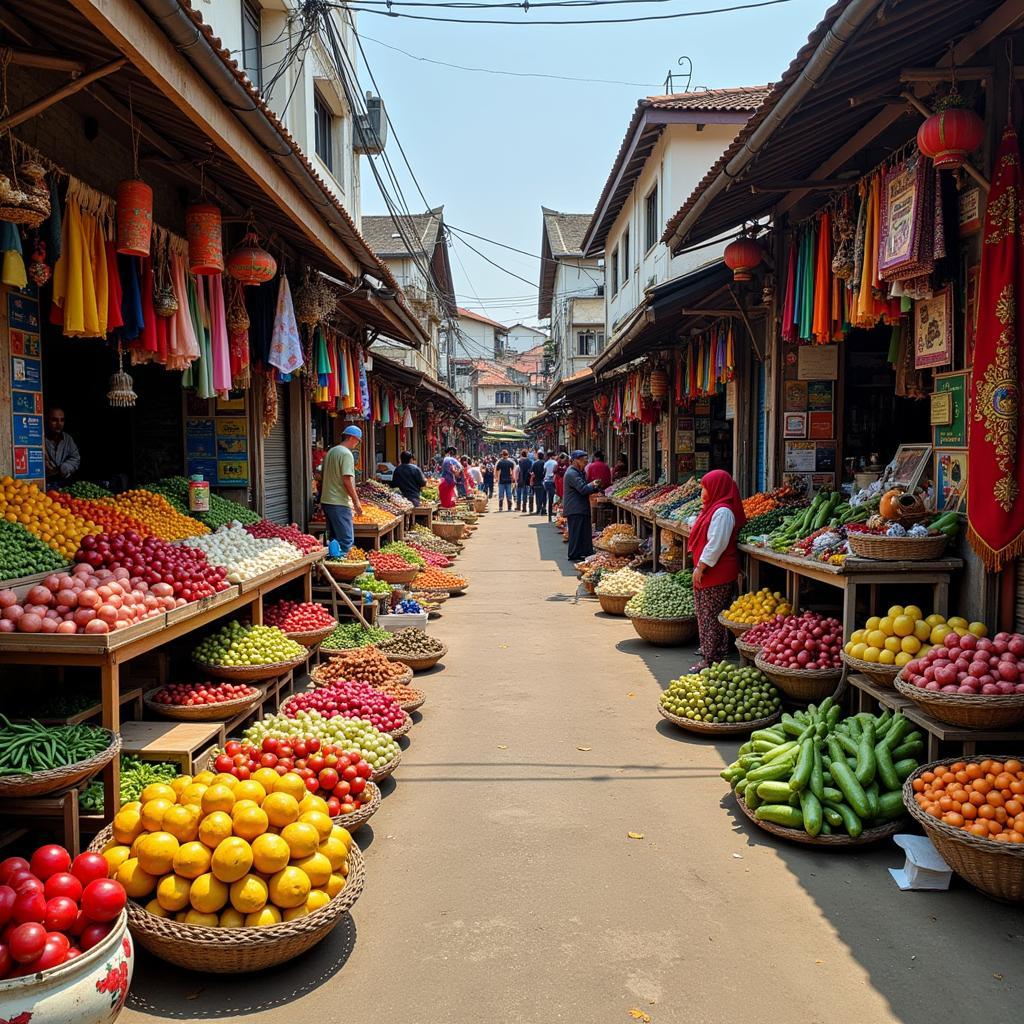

{"left": 722, "top": 697, "right": 925, "bottom": 839}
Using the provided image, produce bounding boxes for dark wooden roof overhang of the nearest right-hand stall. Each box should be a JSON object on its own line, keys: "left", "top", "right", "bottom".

{"left": 662, "top": 0, "right": 1024, "bottom": 254}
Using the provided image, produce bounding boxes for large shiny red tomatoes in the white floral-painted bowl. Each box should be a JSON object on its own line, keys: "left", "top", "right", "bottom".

{"left": 0, "top": 846, "right": 127, "bottom": 978}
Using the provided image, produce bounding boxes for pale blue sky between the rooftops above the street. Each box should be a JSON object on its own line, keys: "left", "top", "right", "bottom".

{"left": 352, "top": 0, "right": 827, "bottom": 325}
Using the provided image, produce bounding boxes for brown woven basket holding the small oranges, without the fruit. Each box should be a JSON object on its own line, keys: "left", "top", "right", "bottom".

{"left": 903, "top": 754, "right": 1024, "bottom": 903}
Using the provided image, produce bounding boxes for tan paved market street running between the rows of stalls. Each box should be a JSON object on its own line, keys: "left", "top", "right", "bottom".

{"left": 121, "top": 506, "right": 1024, "bottom": 1024}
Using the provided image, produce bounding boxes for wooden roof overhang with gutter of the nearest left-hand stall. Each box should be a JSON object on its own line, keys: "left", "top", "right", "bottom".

{"left": 0, "top": 0, "right": 428, "bottom": 347}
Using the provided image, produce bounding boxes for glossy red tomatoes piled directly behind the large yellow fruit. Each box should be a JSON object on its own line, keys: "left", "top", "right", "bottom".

{"left": 214, "top": 736, "right": 373, "bottom": 817}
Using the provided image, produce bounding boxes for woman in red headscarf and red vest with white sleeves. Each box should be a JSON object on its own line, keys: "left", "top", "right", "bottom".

{"left": 689, "top": 469, "right": 746, "bottom": 668}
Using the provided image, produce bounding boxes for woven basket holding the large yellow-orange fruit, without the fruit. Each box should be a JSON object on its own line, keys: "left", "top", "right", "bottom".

{"left": 89, "top": 825, "right": 366, "bottom": 974}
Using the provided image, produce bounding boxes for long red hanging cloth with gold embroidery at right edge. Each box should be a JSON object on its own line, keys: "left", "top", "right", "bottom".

{"left": 967, "top": 127, "right": 1024, "bottom": 572}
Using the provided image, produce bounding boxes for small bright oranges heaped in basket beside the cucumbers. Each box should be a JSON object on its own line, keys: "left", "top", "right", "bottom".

{"left": 911, "top": 758, "right": 1024, "bottom": 843}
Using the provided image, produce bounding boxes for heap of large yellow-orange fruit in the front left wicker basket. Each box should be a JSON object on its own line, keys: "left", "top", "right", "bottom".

{"left": 102, "top": 768, "right": 352, "bottom": 928}
